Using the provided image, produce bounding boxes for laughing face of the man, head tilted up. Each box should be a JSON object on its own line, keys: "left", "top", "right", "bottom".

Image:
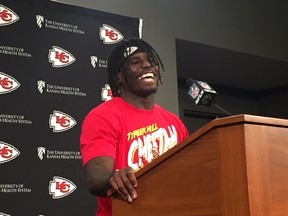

{"left": 122, "top": 52, "right": 159, "bottom": 97}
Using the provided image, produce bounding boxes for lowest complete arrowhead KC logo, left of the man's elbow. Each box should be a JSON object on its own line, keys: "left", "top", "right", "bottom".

{"left": 49, "top": 176, "right": 77, "bottom": 199}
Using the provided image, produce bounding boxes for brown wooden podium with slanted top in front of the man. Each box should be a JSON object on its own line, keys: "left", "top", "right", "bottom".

{"left": 112, "top": 115, "right": 288, "bottom": 216}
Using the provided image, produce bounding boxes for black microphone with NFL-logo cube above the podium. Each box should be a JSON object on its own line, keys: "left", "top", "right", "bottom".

{"left": 186, "top": 78, "right": 232, "bottom": 116}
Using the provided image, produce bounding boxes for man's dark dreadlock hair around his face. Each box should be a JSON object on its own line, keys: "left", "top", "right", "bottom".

{"left": 107, "top": 38, "right": 164, "bottom": 97}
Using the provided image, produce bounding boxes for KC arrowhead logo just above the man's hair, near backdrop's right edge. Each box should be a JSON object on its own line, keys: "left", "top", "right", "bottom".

{"left": 99, "top": 24, "right": 124, "bottom": 44}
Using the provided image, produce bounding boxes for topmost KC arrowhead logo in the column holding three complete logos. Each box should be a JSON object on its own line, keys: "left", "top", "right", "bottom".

{"left": 48, "top": 46, "right": 76, "bottom": 68}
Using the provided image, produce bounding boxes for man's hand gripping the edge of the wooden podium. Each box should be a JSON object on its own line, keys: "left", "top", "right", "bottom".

{"left": 108, "top": 166, "right": 138, "bottom": 203}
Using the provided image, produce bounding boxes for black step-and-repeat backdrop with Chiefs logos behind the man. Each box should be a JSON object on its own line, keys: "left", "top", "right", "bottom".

{"left": 0, "top": 0, "right": 142, "bottom": 216}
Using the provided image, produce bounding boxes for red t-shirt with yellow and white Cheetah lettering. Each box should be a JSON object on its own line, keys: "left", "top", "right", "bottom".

{"left": 80, "top": 97, "right": 188, "bottom": 216}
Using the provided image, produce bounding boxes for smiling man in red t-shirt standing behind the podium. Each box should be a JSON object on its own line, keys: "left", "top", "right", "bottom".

{"left": 80, "top": 38, "right": 188, "bottom": 216}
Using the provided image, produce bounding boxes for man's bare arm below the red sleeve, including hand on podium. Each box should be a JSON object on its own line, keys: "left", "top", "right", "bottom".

{"left": 85, "top": 156, "right": 137, "bottom": 202}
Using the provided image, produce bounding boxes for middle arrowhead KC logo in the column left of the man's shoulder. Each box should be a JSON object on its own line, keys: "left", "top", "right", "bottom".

{"left": 49, "top": 110, "right": 77, "bottom": 132}
